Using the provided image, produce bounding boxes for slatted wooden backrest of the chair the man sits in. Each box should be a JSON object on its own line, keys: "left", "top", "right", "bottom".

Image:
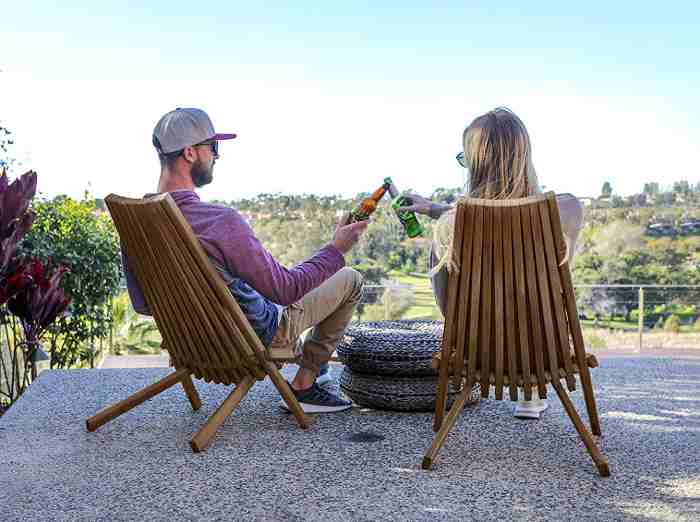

{"left": 105, "top": 194, "right": 265, "bottom": 384}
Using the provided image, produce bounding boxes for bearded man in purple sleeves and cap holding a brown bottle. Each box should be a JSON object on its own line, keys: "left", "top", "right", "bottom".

{"left": 124, "top": 108, "right": 367, "bottom": 413}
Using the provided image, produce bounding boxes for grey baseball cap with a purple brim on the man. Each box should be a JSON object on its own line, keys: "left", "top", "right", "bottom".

{"left": 153, "top": 107, "right": 236, "bottom": 154}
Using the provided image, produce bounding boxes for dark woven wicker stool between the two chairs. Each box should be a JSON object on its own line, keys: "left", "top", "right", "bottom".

{"left": 337, "top": 320, "right": 480, "bottom": 411}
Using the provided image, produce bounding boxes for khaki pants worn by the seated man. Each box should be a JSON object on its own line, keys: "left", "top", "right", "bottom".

{"left": 270, "top": 267, "right": 362, "bottom": 375}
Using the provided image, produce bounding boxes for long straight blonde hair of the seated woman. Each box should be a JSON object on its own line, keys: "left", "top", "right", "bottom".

{"left": 431, "top": 107, "right": 568, "bottom": 274}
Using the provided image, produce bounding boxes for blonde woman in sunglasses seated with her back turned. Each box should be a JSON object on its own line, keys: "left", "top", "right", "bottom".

{"left": 401, "top": 107, "right": 583, "bottom": 419}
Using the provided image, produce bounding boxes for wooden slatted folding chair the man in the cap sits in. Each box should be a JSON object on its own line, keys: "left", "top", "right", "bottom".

{"left": 87, "top": 194, "right": 309, "bottom": 452}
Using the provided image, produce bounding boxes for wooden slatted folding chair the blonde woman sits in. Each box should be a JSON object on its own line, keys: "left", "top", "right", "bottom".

{"left": 423, "top": 192, "right": 610, "bottom": 476}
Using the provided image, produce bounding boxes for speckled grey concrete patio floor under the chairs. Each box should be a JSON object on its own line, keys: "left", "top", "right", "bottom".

{"left": 0, "top": 357, "right": 700, "bottom": 522}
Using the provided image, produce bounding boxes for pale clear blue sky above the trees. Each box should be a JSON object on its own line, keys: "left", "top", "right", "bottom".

{"left": 0, "top": 1, "right": 700, "bottom": 199}
